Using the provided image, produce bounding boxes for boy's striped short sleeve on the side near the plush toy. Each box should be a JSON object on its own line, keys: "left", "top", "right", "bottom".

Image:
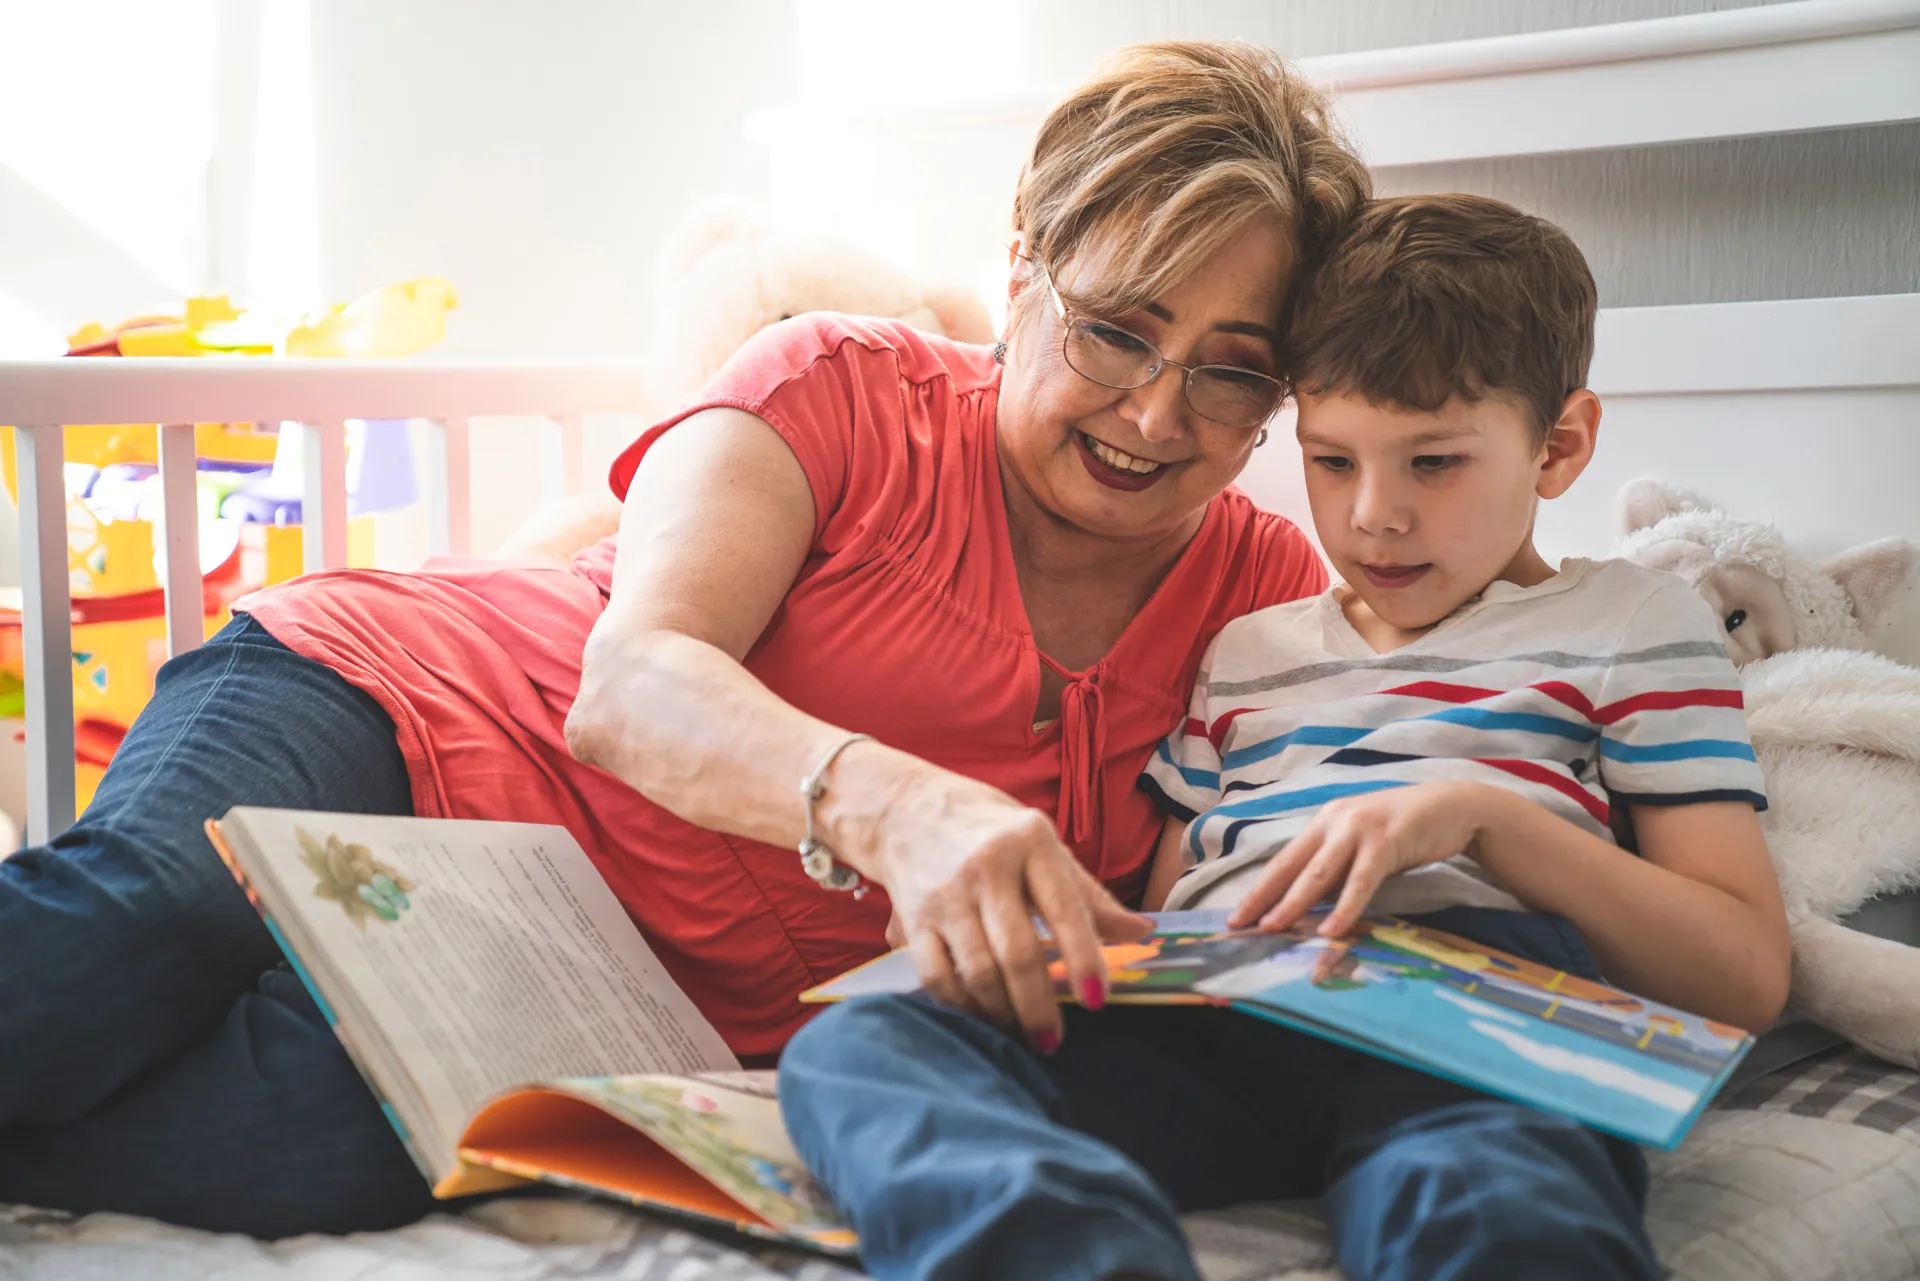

{"left": 1594, "top": 582, "right": 1766, "bottom": 809}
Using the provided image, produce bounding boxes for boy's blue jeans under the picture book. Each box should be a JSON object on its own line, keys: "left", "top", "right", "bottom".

{"left": 780, "top": 908, "right": 1663, "bottom": 1281}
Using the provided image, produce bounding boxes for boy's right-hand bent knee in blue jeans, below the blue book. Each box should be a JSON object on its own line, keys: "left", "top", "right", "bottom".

{"left": 1327, "top": 1102, "right": 1661, "bottom": 1281}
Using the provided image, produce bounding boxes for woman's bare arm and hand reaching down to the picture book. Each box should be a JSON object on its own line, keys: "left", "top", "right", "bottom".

{"left": 566, "top": 409, "right": 1144, "bottom": 1047}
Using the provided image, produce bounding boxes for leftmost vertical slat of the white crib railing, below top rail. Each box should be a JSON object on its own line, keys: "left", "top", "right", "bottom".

{"left": 13, "top": 426, "right": 73, "bottom": 845}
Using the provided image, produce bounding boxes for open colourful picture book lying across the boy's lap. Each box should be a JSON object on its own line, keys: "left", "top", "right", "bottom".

{"left": 801, "top": 912, "right": 1753, "bottom": 1148}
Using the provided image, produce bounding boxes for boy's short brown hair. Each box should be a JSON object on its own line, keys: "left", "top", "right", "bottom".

{"left": 1286, "top": 196, "right": 1597, "bottom": 440}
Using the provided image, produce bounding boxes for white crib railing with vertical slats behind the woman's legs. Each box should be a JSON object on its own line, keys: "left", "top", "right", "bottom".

{"left": 0, "top": 359, "right": 643, "bottom": 843}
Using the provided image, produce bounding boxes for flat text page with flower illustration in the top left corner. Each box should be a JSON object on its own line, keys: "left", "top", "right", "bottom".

{"left": 223, "top": 809, "right": 739, "bottom": 1150}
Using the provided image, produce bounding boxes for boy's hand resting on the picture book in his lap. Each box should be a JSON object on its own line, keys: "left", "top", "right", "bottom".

{"left": 1227, "top": 782, "right": 1513, "bottom": 937}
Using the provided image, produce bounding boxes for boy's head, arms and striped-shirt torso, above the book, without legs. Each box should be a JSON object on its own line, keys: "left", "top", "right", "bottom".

{"left": 1142, "top": 196, "right": 1788, "bottom": 1027}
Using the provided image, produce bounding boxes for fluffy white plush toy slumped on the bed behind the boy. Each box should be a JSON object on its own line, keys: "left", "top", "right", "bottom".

{"left": 1619, "top": 480, "right": 1920, "bottom": 1068}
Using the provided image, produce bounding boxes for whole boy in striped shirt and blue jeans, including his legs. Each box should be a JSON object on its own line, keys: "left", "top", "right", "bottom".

{"left": 781, "top": 196, "right": 1788, "bottom": 1281}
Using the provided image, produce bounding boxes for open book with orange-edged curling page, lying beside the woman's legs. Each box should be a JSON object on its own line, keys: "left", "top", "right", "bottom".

{"left": 207, "top": 809, "right": 856, "bottom": 1254}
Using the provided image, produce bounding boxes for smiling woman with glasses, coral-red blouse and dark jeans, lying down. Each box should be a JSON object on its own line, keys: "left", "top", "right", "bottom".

{"left": 0, "top": 44, "right": 1367, "bottom": 1235}
